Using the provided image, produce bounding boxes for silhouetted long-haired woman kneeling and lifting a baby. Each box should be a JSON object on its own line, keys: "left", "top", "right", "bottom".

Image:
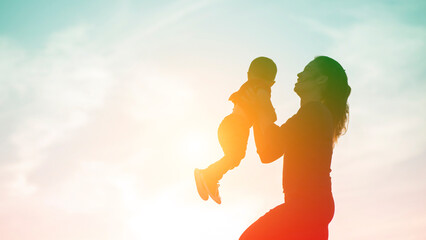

{"left": 240, "top": 56, "right": 351, "bottom": 240}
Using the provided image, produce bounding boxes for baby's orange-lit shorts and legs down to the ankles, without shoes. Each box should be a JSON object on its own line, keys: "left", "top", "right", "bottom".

{"left": 206, "top": 113, "right": 251, "bottom": 181}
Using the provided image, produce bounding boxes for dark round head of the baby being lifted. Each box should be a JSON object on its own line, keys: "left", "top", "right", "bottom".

{"left": 247, "top": 57, "right": 277, "bottom": 83}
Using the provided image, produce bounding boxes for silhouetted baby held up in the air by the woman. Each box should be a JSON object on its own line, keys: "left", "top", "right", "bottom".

{"left": 194, "top": 57, "right": 277, "bottom": 204}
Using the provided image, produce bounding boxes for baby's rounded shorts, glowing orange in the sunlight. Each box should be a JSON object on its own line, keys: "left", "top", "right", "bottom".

{"left": 218, "top": 113, "right": 251, "bottom": 160}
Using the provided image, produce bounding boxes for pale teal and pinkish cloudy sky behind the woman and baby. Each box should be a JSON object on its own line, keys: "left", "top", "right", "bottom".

{"left": 0, "top": 0, "right": 426, "bottom": 240}
